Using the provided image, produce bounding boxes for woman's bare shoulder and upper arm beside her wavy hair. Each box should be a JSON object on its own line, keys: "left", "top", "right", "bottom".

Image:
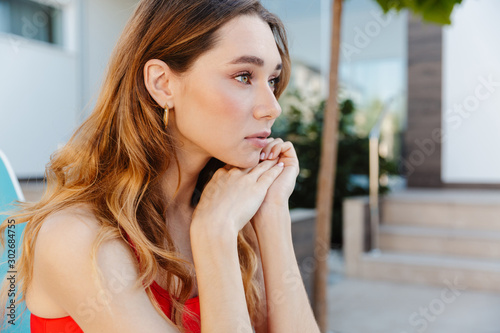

{"left": 27, "top": 206, "right": 176, "bottom": 332}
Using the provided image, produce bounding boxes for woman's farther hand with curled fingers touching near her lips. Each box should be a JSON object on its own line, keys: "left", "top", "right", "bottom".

{"left": 261, "top": 138, "right": 299, "bottom": 207}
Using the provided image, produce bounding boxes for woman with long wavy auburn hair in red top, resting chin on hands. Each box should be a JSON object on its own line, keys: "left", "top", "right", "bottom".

{"left": 2, "top": 0, "right": 318, "bottom": 332}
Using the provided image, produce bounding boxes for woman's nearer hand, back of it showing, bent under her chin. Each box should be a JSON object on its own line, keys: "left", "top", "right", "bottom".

{"left": 192, "top": 159, "right": 284, "bottom": 234}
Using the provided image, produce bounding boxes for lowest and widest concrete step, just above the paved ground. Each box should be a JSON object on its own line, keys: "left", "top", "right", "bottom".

{"left": 356, "top": 251, "right": 500, "bottom": 292}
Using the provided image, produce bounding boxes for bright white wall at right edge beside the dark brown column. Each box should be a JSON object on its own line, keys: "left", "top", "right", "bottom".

{"left": 442, "top": 0, "right": 500, "bottom": 183}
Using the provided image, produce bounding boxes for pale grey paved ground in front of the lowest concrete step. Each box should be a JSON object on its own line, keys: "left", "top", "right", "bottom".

{"left": 328, "top": 251, "right": 500, "bottom": 333}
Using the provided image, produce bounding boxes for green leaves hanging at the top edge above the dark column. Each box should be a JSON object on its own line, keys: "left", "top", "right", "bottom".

{"left": 376, "top": 0, "right": 462, "bottom": 25}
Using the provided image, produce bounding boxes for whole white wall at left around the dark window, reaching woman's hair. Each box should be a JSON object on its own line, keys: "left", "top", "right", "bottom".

{"left": 0, "top": 0, "right": 137, "bottom": 178}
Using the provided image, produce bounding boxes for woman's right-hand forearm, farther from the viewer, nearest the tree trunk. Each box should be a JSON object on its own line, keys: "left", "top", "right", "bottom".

{"left": 254, "top": 207, "right": 319, "bottom": 333}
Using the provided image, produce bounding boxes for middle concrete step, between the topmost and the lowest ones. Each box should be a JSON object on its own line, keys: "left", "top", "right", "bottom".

{"left": 379, "top": 224, "right": 500, "bottom": 260}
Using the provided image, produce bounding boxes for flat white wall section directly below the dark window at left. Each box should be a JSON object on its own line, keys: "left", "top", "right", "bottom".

{"left": 0, "top": 35, "right": 77, "bottom": 178}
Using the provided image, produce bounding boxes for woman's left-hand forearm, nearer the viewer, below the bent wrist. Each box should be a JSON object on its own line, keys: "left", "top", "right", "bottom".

{"left": 191, "top": 219, "right": 251, "bottom": 333}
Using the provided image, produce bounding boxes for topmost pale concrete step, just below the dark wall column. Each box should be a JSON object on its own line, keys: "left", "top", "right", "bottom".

{"left": 381, "top": 189, "right": 500, "bottom": 231}
